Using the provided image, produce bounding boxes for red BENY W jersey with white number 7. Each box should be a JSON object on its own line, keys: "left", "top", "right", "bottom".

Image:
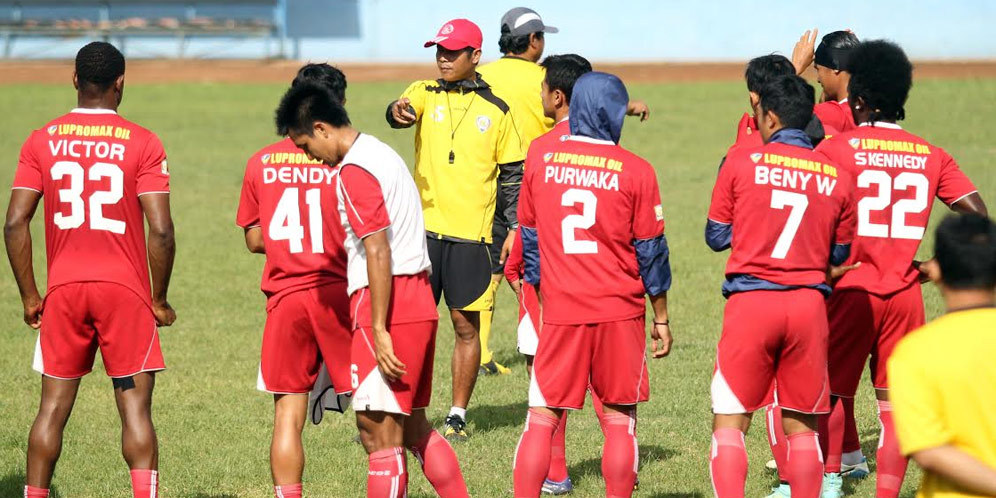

{"left": 709, "top": 143, "right": 854, "bottom": 286}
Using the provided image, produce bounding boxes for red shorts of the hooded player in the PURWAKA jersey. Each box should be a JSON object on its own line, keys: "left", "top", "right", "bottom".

{"left": 529, "top": 316, "right": 650, "bottom": 410}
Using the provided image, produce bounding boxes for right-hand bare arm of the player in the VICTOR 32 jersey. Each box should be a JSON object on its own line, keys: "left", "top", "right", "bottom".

{"left": 138, "top": 193, "right": 176, "bottom": 327}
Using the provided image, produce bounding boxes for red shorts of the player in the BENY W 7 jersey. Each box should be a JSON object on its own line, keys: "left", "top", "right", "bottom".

{"left": 712, "top": 289, "right": 830, "bottom": 415}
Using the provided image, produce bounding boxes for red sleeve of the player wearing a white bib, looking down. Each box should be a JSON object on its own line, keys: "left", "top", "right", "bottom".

{"left": 339, "top": 164, "right": 391, "bottom": 239}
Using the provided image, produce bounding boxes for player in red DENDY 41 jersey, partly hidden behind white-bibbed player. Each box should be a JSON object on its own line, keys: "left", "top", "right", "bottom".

{"left": 236, "top": 64, "right": 352, "bottom": 498}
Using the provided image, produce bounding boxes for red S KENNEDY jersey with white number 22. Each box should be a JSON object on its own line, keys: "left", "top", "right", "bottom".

{"left": 816, "top": 123, "right": 976, "bottom": 296}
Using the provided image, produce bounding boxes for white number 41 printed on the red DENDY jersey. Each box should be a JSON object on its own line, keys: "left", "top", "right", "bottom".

{"left": 268, "top": 187, "right": 325, "bottom": 254}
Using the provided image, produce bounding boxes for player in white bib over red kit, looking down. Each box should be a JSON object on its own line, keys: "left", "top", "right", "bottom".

{"left": 277, "top": 85, "right": 467, "bottom": 498}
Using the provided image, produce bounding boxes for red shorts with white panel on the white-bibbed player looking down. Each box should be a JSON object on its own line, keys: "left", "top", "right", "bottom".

{"left": 350, "top": 320, "right": 439, "bottom": 415}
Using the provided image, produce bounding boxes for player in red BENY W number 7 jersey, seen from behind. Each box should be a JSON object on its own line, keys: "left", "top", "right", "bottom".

{"left": 706, "top": 75, "right": 854, "bottom": 498}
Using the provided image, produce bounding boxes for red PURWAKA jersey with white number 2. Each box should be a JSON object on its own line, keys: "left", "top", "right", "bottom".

{"left": 519, "top": 136, "right": 664, "bottom": 325}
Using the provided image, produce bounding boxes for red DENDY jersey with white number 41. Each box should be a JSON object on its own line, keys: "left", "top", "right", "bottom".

{"left": 236, "top": 138, "right": 346, "bottom": 306}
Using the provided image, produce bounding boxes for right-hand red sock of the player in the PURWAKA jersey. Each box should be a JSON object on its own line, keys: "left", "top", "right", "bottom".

{"left": 602, "top": 410, "right": 640, "bottom": 497}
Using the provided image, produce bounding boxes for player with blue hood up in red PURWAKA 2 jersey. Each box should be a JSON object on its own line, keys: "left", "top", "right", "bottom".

{"left": 514, "top": 72, "right": 671, "bottom": 497}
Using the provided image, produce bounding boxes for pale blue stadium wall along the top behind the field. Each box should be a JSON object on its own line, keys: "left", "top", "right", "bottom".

{"left": 7, "top": 0, "right": 996, "bottom": 62}
